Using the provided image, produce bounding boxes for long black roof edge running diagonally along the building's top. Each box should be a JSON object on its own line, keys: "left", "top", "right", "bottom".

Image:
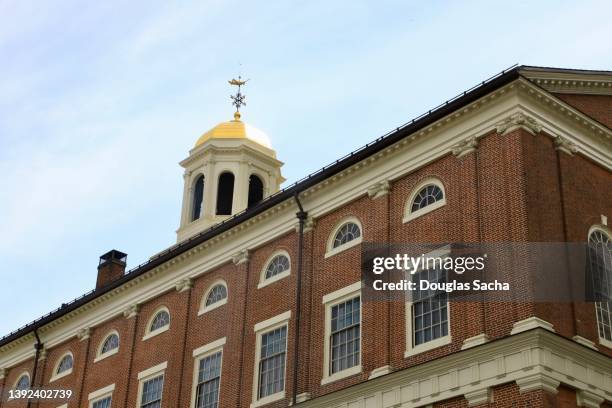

{"left": 0, "top": 64, "right": 522, "bottom": 347}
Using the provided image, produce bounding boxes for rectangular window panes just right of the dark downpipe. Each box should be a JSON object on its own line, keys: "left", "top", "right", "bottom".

{"left": 330, "top": 297, "right": 361, "bottom": 374}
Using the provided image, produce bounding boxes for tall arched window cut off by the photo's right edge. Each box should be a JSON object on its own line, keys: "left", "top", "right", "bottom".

{"left": 588, "top": 228, "right": 612, "bottom": 347}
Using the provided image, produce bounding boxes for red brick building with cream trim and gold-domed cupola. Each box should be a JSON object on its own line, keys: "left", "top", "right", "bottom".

{"left": 0, "top": 66, "right": 612, "bottom": 408}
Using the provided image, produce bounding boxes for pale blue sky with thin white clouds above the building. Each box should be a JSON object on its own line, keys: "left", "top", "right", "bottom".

{"left": 0, "top": 0, "right": 612, "bottom": 336}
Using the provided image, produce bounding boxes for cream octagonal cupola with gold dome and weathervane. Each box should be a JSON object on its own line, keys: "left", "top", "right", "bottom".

{"left": 177, "top": 77, "right": 285, "bottom": 242}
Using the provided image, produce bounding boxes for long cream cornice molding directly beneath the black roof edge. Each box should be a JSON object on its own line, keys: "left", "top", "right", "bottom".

{"left": 0, "top": 75, "right": 612, "bottom": 367}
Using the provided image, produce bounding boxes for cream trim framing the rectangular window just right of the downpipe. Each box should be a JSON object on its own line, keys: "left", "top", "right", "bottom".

{"left": 321, "top": 281, "right": 363, "bottom": 385}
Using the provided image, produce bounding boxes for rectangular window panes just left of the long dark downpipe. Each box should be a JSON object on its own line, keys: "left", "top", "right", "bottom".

{"left": 258, "top": 326, "right": 287, "bottom": 398}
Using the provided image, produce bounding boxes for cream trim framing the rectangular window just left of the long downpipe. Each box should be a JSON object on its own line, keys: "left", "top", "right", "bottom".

{"left": 251, "top": 310, "right": 291, "bottom": 408}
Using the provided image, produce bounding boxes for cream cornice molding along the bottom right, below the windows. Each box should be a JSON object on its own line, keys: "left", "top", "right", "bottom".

{"left": 304, "top": 329, "right": 612, "bottom": 408}
